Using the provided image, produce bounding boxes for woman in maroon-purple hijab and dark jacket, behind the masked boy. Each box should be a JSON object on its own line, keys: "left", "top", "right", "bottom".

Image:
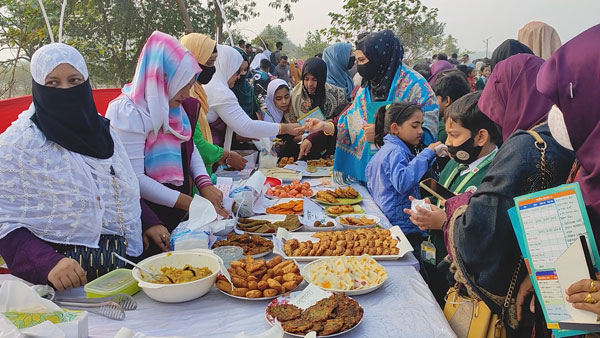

{"left": 418, "top": 55, "right": 576, "bottom": 337}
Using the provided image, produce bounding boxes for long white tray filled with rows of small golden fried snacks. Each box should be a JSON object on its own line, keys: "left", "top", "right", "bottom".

{"left": 273, "top": 226, "right": 412, "bottom": 262}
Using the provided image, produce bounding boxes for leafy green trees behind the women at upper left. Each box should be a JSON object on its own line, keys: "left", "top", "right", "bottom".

{"left": 0, "top": 0, "right": 298, "bottom": 93}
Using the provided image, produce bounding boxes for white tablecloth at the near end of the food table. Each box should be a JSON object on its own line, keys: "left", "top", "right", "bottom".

{"left": 83, "top": 262, "right": 454, "bottom": 338}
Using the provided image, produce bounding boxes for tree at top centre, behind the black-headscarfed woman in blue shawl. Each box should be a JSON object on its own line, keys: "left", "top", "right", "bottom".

{"left": 321, "top": 0, "right": 445, "bottom": 61}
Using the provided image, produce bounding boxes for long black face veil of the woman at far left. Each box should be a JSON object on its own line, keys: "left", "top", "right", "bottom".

{"left": 31, "top": 80, "right": 114, "bottom": 159}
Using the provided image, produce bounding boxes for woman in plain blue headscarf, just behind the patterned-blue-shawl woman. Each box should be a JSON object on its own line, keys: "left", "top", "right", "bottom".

{"left": 323, "top": 42, "right": 355, "bottom": 101}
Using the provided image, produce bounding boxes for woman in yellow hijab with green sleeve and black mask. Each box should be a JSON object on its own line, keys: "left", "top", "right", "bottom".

{"left": 179, "top": 33, "right": 247, "bottom": 174}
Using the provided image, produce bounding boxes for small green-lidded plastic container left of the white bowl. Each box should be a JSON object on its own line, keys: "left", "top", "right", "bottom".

{"left": 84, "top": 269, "right": 140, "bottom": 298}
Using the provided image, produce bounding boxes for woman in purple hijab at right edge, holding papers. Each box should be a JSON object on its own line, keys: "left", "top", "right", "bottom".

{"left": 537, "top": 25, "right": 600, "bottom": 314}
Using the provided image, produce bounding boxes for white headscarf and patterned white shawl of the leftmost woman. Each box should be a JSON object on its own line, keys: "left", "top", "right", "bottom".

{"left": 0, "top": 43, "right": 142, "bottom": 256}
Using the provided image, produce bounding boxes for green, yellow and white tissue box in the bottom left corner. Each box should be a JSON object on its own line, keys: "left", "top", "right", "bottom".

{"left": 2, "top": 309, "right": 88, "bottom": 338}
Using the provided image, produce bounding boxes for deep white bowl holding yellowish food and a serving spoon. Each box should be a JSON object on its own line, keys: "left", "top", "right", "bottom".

{"left": 132, "top": 249, "right": 222, "bottom": 303}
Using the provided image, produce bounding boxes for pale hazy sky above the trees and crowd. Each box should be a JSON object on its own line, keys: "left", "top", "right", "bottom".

{"left": 238, "top": 0, "right": 600, "bottom": 55}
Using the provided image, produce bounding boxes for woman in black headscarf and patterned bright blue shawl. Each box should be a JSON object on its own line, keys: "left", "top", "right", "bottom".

{"left": 333, "top": 30, "right": 439, "bottom": 183}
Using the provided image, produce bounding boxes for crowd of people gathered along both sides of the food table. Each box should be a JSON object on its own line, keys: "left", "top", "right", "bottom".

{"left": 0, "top": 17, "right": 600, "bottom": 337}
